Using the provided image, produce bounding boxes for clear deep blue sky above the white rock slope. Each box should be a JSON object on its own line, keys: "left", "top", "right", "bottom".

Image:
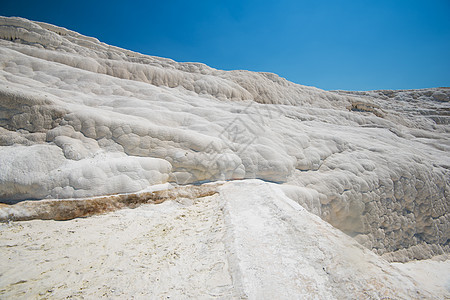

{"left": 0, "top": 0, "right": 450, "bottom": 90}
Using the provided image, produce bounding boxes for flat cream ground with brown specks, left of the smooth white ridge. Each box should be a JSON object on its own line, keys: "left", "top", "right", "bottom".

{"left": 0, "top": 196, "right": 233, "bottom": 299}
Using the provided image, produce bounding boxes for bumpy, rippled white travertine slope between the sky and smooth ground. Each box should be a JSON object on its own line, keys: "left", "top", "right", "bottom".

{"left": 0, "top": 18, "right": 450, "bottom": 260}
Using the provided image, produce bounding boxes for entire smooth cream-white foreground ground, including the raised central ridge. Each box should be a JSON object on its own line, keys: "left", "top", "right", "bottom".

{"left": 0, "top": 180, "right": 449, "bottom": 300}
